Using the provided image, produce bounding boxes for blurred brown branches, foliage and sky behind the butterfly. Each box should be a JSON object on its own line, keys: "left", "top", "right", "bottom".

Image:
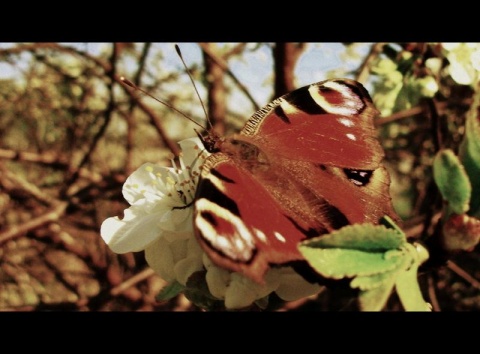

{"left": 0, "top": 43, "right": 480, "bottom": 311}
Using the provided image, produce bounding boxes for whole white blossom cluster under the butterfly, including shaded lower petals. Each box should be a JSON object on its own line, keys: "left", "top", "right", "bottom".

{"left": 100, "top": 138, "right": 321, "bottom": 309}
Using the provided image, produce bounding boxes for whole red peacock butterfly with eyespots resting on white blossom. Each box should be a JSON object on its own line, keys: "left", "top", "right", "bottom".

{"left": 193, "top": 79, "right": 398, "bottom": 283}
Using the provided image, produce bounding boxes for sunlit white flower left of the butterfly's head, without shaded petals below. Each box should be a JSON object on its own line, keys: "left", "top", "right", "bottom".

{"left": 100, "top": 138, "right": 208, "bottom": 253}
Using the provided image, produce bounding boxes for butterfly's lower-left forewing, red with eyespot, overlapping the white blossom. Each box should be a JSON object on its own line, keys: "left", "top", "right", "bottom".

{"left": 194, "top": 154, "right": 306, "bottom": 283}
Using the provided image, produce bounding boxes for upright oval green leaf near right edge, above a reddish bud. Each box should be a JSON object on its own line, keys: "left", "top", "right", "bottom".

{"left": 433, "top": 149, "right": 472, "bottom": 214}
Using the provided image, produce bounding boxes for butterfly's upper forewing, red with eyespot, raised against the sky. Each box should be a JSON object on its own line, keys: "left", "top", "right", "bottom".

{"left": 242, "top": 79, "right": 384, "bottom": 170}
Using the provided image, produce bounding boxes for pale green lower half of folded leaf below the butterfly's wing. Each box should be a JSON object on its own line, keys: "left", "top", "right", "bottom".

{"left": 299, "top": 246, "right": 403, "bottom": 279}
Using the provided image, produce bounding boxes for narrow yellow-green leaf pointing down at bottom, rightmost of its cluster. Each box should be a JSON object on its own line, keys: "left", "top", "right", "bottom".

{"left": 395, "top": 263, "right": 431, "bottom": 311}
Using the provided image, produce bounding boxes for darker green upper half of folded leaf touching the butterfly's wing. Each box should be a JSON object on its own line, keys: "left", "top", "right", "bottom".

{"left": 300, "top": 224, "right": 407, "bottom": 252}
